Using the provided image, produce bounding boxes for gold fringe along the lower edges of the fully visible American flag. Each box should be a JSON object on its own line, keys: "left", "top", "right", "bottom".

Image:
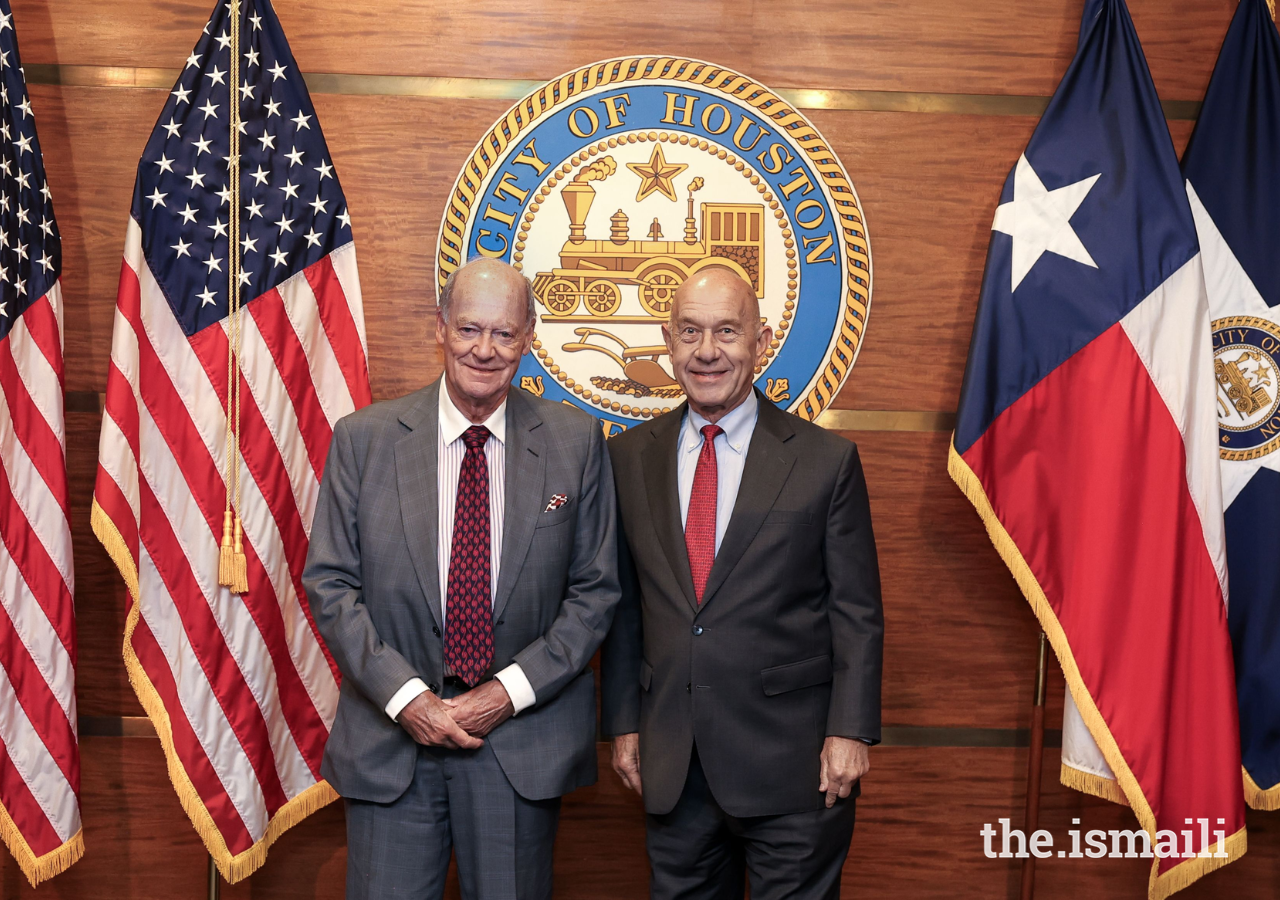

{"left": 89, "top": 491, "right": 338, "bottom": 885}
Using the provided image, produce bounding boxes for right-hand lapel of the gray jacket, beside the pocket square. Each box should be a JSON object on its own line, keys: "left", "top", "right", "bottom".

{"left": 493, "top": 390, "right": 547, "bottom": 620}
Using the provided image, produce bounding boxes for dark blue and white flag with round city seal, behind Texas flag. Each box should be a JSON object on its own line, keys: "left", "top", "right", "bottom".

{"left": 1183, "top": 0, "right": 1280, "bottom": 809}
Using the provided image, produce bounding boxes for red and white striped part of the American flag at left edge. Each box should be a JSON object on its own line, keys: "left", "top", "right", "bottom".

{"left": 0, "top": 283, "right": 83, "bottom": 885}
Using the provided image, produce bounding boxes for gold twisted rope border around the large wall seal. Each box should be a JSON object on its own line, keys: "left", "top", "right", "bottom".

{"left": 436, "top": 56, "right": 872, "bottom": 421}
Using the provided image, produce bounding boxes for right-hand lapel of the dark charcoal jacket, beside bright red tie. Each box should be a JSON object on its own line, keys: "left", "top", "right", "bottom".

{"left": 685, "top": 394, "right": 796, "bottom": 609}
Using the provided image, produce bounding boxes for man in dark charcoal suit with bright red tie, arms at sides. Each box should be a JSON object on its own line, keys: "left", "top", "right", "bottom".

{"left": 602, "top": 268, "right": 883, "bottom": 900}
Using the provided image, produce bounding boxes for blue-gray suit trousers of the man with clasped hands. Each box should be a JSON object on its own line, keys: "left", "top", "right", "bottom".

{"left": 346, "top": 727, "right": 561, "bottom": 900}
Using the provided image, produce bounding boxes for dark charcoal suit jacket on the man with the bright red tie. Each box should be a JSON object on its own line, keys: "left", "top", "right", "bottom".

{"left": 602, "top": 396, "right": 883, "bottom": 816}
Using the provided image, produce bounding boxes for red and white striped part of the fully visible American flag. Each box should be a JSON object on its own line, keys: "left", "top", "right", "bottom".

{"left": 95, "top": 219, "right": 370, "bottom": 876}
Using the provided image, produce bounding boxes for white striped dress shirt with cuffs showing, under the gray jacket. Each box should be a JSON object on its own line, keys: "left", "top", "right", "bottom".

{"left": 385, "top": 379, "right": 538, "bottom": 718}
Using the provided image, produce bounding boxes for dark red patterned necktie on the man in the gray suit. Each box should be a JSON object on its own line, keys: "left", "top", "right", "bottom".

{"left": 444, "top": 425, "right": 493, "bottom": 687}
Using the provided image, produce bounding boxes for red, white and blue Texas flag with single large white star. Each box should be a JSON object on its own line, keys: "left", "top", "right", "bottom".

{"left": 948, "top": 0, "right": 1245, "bottom": 899}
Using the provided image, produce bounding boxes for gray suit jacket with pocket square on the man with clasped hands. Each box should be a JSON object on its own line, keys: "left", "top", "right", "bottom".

{"left": 303, "top": 382, "right": 618, "bottom": 803}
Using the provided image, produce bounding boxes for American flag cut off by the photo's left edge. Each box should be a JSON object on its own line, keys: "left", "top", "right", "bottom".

{"left": 0, "top": 0, "right": 84, "bottom": 885}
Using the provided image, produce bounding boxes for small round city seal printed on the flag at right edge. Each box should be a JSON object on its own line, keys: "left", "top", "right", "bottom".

{"left": 1213, "top": 316, "right": 1280, "bottom": 460}
